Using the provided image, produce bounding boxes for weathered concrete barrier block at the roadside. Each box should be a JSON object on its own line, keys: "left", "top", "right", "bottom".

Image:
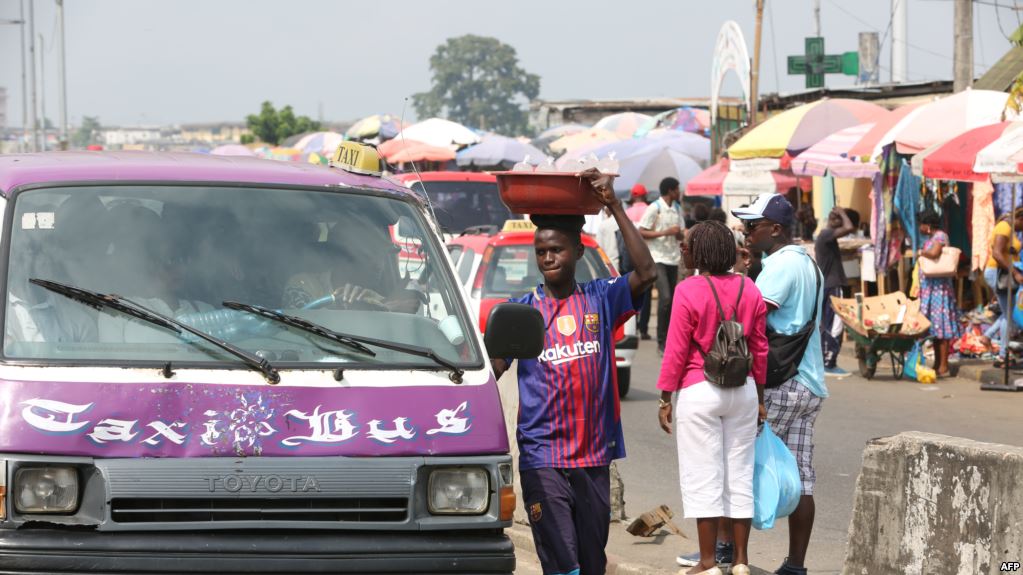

{"left": 842, "top": 432, "right": 1023, "bottom": 575}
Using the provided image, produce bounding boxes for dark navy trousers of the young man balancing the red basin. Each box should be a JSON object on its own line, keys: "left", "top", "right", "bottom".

{"left": 520, "top": 467, "right": 611, "bottom": 575}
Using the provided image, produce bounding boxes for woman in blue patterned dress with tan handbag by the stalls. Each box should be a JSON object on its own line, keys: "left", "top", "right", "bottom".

{"left": 917, "top": 210, "right": 963, "bottom": 375}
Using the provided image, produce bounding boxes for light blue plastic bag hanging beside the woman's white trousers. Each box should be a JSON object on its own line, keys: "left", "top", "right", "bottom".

{"left": 753, "top": 422, "right": 803, "bottom": 529}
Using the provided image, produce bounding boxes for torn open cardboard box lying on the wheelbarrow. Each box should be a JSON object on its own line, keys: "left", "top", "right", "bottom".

{"left": 831, "top": 292, "right": 931, "bottom": 338}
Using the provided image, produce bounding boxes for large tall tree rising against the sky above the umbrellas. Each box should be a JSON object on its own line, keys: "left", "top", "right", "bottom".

{"left": 412, "top": 34, "right": 540, "bottom": 135}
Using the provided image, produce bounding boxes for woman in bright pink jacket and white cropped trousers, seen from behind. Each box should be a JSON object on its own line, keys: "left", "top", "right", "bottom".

{"left": 657, "top": 221, "right": 767, "bottom": 575}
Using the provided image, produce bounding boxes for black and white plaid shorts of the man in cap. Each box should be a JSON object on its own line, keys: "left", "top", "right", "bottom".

{"left": 764, "top": 380, "right": 824, "bottom": 495}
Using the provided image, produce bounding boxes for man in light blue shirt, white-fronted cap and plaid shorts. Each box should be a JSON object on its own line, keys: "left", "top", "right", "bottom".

{"left": 732, "top": 193, "right": 828, "bottom": 575}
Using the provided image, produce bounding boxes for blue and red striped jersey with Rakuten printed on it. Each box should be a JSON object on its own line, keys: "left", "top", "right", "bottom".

{"left": 512, "top": 275, "right": 635, "bottom": 470}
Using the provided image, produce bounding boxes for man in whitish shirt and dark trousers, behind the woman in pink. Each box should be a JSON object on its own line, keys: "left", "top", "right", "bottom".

{"left": 639, "top": 178, "right": 684, "bottom": 355}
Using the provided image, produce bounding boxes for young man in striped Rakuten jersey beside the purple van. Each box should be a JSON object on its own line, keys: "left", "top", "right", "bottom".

{"left": 491, "top": 170, "right": 656, "bottom": 575}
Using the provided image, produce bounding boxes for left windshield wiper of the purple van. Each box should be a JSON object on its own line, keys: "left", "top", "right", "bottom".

{"left": 29, "top": 277, "right": 280, "bottom": 385}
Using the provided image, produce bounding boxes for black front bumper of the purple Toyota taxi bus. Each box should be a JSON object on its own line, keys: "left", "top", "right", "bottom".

{"left": 0, "top": 529, "right": 515, "bottom": 575}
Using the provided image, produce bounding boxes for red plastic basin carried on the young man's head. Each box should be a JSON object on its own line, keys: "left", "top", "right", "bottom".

{"left": 494, "top": 172, "right": 604, "bottom": 215}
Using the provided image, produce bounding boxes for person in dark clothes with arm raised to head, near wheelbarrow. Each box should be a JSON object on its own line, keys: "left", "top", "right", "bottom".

{"left": 813, "top": 206, "right": 859, "bottom": 378}
